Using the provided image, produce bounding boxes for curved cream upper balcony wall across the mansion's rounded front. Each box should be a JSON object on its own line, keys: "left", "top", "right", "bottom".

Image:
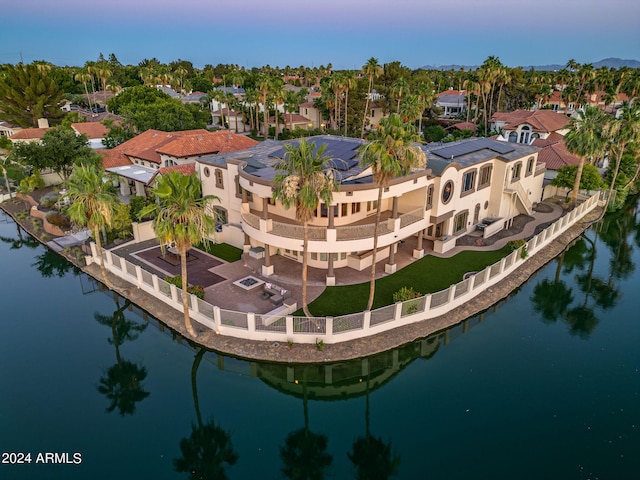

{"left": 241, "top": 208, "right": 426, "bottom": 252}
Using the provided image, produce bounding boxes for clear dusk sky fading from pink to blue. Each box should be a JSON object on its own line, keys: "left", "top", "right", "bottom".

{"left": 0, "top": 0, "right": 640, "bottom": 69}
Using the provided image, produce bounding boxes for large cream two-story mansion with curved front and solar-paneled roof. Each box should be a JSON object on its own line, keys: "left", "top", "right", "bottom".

{"left": 197, "top": 135, "right": 544, "bottom": 284}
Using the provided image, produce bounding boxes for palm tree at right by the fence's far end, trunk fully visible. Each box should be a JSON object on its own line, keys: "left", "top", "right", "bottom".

{"left": 564, "top": 106, "right": 606, "bottom": 205}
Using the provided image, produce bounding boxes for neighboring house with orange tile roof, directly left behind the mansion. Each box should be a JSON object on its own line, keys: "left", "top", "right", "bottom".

{"left": 100, "top": 129, "right": 257, "bottom": 199}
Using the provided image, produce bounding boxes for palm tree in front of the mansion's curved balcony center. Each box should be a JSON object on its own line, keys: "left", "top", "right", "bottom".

{"left": 273, "top": 140, "right": 337, "bottom": 317}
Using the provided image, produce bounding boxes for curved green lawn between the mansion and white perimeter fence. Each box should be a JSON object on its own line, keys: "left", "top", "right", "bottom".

{"left": 304, "top": 247, "right": 511, "bottom": 316}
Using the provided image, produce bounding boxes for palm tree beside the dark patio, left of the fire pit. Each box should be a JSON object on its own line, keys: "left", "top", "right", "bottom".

{"left": 140, "top": 170, "right": 219, "bottom": 337}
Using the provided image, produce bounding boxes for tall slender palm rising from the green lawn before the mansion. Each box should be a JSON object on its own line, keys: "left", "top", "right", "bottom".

{"left": 358, "top": 113, "right": 427, "bottom": 310}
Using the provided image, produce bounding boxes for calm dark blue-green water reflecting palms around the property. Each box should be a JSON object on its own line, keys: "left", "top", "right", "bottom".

{"left": 0, "top": 200, "right": 640, "bottom": 480}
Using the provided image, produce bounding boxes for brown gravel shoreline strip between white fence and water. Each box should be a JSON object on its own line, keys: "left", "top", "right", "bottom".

{"left": 0, "top": 199, "right": 602, "bottom": 364}
